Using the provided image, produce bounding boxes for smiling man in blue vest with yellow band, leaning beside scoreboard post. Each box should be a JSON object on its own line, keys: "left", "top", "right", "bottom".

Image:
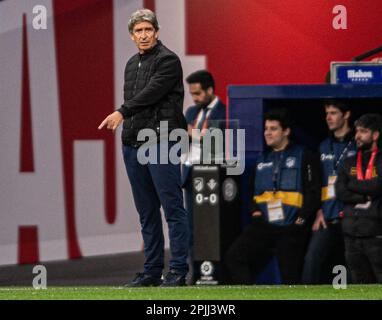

{"left": 225, "top": 110, "right": 320, "bottom": 284}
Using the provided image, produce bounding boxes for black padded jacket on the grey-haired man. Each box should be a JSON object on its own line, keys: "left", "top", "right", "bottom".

{"left": 118, "top": 41, "right": 187, "bottom": 147}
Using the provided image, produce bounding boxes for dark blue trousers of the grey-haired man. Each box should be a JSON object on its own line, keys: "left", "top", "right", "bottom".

{"left": 123, "top": 142, "right": 189, "bottom": 276}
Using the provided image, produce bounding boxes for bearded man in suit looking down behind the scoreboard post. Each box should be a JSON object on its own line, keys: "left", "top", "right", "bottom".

{"left": 182, "top": 70, "right": 226, "bottom": 282}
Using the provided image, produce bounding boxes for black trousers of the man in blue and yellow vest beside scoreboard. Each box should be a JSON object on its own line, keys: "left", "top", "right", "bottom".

{"left": 225, "top": 218, "right": 309, "bottom": 285}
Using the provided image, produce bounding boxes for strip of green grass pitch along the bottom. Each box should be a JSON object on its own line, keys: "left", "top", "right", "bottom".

{"left": 0, "top": 285, "right": 382, "bottom": 300}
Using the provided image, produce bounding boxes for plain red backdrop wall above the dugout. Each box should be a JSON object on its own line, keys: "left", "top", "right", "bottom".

{"left": 186, "top": 0, "right": 382, "bottom": 96}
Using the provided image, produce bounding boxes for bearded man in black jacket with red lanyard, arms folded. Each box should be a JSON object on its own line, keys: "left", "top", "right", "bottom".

{"left": 336, "top": 114, "right": 382, "bottom": 283}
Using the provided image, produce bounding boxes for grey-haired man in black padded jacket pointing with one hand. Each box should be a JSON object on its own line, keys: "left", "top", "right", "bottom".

{"left": 99, "top": 9, "right": 189, "bottom": 287}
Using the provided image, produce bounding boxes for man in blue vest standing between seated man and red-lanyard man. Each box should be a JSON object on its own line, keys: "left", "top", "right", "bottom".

{"left": 303, "top": 100, "right": 356, "bottom": 284}
